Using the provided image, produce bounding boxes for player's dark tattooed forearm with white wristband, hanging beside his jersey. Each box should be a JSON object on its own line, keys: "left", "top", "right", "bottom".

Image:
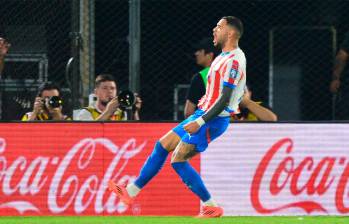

{"left": 199, "top": 86, "right": 233, "bottom": 126}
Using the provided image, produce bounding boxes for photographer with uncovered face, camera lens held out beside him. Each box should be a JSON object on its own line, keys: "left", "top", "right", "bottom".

{"left": 77, "top": 74, "right": 142, "bottom": 121}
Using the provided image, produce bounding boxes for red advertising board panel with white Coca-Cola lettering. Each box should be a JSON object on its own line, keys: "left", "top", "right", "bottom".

{"left": 0, "top": 123, "right": 200, "bottom": 215}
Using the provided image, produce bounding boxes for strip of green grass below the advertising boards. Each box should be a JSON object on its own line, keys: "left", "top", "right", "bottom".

{"left": 0, "top": 216, "right": 349, "bottom": 224}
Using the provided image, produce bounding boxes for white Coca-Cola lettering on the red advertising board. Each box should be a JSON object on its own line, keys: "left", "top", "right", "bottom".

{"left": 0, "top": 138, "right": 146, "bottom": 214}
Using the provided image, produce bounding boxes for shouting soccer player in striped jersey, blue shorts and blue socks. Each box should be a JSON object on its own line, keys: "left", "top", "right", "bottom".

{"left": 109, "top": 16, "right": 246, "bottom": 217}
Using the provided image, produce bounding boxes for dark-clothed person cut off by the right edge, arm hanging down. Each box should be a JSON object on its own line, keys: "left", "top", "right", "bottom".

{"left": 330, "top": 31, "right": 349, "bottom": 120}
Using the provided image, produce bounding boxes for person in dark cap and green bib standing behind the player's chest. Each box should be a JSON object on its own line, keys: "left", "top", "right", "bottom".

{"left": 184, "top": 38, "right": 219, "bottom": 118}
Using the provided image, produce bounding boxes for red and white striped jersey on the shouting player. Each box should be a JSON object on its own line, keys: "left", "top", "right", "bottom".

{"left": 198, "top": 48, "right": 246, "bottom": 117}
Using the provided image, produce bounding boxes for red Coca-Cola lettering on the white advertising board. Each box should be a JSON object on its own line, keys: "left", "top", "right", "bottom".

{"left": 250, "top": 138, "right": 349, "bottom": 214}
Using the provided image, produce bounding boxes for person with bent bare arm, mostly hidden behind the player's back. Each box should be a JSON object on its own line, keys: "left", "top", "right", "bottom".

{"left": 232, "top": 87, "right": 277, "bottom": 121}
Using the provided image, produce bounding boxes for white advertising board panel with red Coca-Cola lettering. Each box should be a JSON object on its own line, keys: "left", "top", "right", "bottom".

{"left": 200, "top": 123, "right": 349, "bottom": 216}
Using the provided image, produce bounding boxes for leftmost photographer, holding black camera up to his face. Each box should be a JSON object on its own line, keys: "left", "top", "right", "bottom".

{"left": 22, "top": 83, "right": 70, "bottom": 121}
